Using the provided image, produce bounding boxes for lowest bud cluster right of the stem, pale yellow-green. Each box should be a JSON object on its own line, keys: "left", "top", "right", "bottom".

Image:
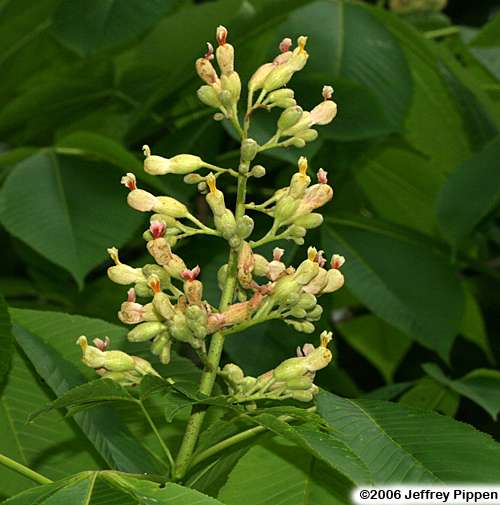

{"left": 221, "top": 331, "right": 332, "bottom": 403}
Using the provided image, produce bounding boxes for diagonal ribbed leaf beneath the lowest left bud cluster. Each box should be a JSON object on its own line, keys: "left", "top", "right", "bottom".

{"left": 11, "top": 309, "right": 165, "bottom": 473}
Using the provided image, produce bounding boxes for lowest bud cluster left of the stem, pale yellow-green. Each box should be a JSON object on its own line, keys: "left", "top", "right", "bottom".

{"left": 76, "top": 335, "right": 160, "bottom": 386}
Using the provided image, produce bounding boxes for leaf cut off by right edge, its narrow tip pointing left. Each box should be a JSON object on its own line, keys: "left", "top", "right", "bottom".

{"left": 422, "top": 363, "right": 500, "bottom": 420}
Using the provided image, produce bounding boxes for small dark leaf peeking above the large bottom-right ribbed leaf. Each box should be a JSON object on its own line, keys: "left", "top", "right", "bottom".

{"left": 399, "top": 377, "right": 460, "bottom": 417}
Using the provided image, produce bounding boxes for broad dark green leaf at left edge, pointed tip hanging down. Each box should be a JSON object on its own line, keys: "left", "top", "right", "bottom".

{"left": 0, "top": 151, "right": 143, "bottom": 287}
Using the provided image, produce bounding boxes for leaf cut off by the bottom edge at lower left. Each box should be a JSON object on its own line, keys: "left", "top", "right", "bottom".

{"left": 5, "top": 471, "right": 227, "bottom": 505}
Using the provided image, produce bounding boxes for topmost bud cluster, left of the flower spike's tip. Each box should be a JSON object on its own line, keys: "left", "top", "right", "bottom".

{"left": 196, "top": 26, "right": 241, "bottom": 119}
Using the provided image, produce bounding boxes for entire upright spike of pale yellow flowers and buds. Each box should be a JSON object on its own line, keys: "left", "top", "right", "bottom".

{"left": 78, "top": 26, "right": 345, "bottom": 402}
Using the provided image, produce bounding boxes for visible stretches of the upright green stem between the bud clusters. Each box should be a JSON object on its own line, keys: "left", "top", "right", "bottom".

{"left": 175, "top": 162, "right": 248, "bottom": 480}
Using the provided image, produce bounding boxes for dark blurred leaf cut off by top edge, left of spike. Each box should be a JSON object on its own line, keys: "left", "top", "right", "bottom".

{"left": 52, "top": 0, "right": 178, "bottom": 56}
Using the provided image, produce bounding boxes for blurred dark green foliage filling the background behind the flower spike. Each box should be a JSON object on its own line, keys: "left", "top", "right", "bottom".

{"left": 0, "top": 0, "right": 500, "bottom": 476}
